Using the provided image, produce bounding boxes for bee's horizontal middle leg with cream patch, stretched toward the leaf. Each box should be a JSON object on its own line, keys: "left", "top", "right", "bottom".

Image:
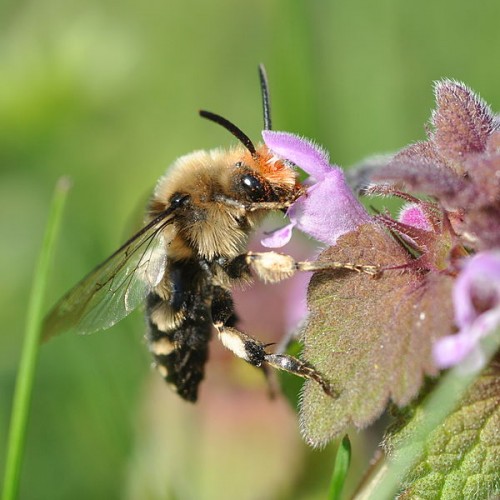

{"left": 227, "top": 252, "right": 381, "bottom": 283}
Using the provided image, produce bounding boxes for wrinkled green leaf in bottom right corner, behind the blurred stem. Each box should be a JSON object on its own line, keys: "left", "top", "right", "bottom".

{"left": 388, "top": 362, "right": 500, "bottom": 499}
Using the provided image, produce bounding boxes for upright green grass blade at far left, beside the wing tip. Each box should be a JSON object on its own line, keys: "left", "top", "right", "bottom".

{"left": 2, "top": 178, "right": 70, "bottom": 500}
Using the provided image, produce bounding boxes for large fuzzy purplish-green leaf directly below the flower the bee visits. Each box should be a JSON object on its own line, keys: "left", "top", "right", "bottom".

{"left": 301, "top": 224, "right": 453, "bottom": 446}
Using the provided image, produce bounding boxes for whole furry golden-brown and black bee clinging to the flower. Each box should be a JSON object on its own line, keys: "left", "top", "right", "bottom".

{"left": 44, "top": 67, "right": 332, "bottom": 402}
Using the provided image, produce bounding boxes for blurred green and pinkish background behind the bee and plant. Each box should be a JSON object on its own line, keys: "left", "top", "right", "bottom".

{"left": 0, "top": 0, "right": 500, "bottom": 500}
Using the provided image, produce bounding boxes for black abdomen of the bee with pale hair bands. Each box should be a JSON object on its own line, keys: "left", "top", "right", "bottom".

{"left": 146, "top": 293, "right": 211, "bottom": 402}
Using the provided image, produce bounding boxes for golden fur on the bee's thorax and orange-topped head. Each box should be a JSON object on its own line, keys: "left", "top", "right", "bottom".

{"left": 150, "top": 146, "right": 296, "bottom": 260}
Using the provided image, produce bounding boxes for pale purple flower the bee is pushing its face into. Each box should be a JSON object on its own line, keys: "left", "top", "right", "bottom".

{"left": 262, "top": 130, "right": 371, "bottom": 248}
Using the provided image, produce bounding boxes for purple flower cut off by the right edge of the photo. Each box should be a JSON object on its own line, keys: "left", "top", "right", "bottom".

{"left": 434, "top": 251, "right": 500, "bottom": 369}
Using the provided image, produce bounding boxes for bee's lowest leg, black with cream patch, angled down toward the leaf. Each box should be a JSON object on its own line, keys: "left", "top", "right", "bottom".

{"left": 214, "top": 322, "right": 335, "bottom": 397}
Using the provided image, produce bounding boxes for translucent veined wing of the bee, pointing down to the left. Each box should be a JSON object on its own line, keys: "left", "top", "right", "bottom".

{"left": 43, "top": 209, "right": 174, "bottom": 340}
